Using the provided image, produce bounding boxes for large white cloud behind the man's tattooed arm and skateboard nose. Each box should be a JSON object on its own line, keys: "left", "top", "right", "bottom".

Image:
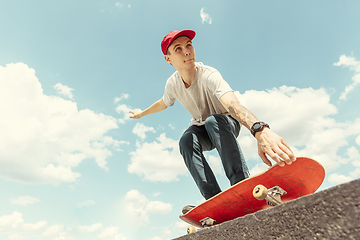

{"left": 236, "top": 86, "right": 360, "bottom": 183}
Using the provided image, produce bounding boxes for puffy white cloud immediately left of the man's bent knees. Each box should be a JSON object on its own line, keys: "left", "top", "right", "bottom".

{"left": 128, "top": 133, "right": 187, "bottom": 182}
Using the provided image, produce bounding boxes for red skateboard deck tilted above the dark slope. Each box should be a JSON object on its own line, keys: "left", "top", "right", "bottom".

{"left": 180, "top": 157, "right": 325, "bottom": 228}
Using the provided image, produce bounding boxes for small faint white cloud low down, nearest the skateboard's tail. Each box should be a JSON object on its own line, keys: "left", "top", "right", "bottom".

{"left": 125, "top": 190, "right": 173, "bottom": 225}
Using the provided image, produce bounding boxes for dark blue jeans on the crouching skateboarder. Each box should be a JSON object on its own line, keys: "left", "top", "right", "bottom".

{"left": 179, "top": 114, "right": 250, "bottom": 199}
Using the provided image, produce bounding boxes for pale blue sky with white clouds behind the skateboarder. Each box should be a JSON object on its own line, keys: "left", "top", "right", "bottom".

{"left": 0, "top": 0, "right": 360, "bottom": 240}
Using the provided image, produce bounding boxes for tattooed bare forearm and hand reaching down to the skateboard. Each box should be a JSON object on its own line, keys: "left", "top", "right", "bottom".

{"left": 220, "top": 92, "right": 296, "bottom": 166}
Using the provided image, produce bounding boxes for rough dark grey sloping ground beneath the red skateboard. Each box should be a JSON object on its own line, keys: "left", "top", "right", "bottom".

{"left": 176, "top": 179, "right": 360, "bottom": 240}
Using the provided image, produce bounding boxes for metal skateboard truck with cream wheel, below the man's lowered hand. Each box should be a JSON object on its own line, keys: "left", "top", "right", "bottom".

{"left": 253, "top": 185, "right": 287, "bottom": 206}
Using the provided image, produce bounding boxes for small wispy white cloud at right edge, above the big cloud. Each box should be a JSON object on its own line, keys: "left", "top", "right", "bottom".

{"left": 334, "top": 55, "right": 360, "bottom": 100}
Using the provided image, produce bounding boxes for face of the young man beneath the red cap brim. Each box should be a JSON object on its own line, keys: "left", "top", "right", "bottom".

{"left": 165, "top": 36, "right": 195, "bottom": 70}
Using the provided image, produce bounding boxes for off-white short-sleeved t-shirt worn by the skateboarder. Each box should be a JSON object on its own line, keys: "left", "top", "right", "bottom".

{"left": 163, "top": 62, "right": 233, "bottom": 125}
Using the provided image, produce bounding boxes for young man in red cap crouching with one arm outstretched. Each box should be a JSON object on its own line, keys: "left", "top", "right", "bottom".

{"left": 130, "top": 30, "right": 296, "bottom": 202}
